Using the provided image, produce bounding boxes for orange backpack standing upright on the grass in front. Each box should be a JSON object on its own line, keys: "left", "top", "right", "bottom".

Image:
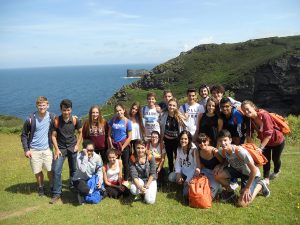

{"left": 189, "top": 175, "right": 212, "bottom": 209}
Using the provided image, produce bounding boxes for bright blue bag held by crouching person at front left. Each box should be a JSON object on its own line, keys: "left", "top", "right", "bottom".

{"left": 84, "top": 175, "right": 104, "bottom": 204}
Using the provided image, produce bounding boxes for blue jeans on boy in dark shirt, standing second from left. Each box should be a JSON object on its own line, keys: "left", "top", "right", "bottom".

{"left": 52, "top": 151, "right": 77, "bottom": 195}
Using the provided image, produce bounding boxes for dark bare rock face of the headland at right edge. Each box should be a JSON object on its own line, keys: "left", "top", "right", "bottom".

{"left": 231, "top": 55, "right": 300, "bottom": 115}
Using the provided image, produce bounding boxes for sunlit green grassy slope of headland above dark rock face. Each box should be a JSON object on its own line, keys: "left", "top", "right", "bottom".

{"left": 149, "top": 36, "right": 300, "bottom": 97}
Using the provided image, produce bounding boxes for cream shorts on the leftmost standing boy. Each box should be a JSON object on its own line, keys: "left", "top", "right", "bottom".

{"left": 30, "top": 148, "right": 53, "bottom": 174}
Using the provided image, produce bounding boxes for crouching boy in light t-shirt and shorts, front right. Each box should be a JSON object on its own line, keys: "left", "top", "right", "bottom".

{"left": 214, "top": 130, "right": 270, "bottom": 207}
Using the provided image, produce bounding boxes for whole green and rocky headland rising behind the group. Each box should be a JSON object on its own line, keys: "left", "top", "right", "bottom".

{"left": 104, "top": 36, "right": 300, "bottom": 115}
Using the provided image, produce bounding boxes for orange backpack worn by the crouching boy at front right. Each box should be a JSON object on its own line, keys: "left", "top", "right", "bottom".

{"left": 222, "top": 143, "right": 268, "bottom": 166}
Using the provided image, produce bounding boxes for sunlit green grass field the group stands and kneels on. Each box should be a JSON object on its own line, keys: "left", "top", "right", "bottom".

{"left": 0, "top": 134, "right": 300, "bottom": 225}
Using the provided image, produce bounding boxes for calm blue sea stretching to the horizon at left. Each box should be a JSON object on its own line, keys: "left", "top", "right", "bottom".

{"left": 0, "top": 64, "right": 155, "bottom": 119}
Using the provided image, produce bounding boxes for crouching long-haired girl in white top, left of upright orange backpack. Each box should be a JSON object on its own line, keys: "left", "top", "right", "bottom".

{"left": 169, "top": 130, "right": 200, "bottom": 200}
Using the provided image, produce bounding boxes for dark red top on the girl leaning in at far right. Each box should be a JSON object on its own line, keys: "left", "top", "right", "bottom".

{"left": 251, "top": 109, "right": 284, "bottom": 147}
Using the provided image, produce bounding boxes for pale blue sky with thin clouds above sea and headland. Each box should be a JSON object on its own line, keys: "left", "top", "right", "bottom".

{"left": 0, "top": 0, "right": 300, "bottom": 68}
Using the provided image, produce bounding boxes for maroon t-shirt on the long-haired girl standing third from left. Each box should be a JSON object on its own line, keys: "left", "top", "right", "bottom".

{"left": 82, "top": 121, "right": 108, "bottom": 150}
